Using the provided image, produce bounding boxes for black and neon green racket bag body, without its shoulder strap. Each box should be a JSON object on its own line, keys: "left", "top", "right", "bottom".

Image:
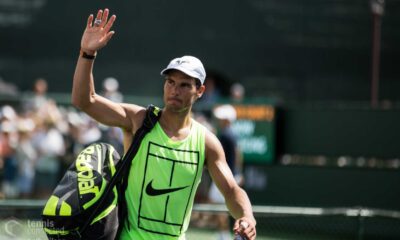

{"left": 42, "top": 143, "right": 121, "bottom": 239}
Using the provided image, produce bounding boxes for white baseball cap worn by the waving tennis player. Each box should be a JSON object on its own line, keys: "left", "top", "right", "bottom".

{"left": 161, "top": 56, "right": 206, "bottom": 84}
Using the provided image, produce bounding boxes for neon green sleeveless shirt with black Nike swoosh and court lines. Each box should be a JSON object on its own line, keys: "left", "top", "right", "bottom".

{"left": 120, "top": 120, "right": 205, "bottom": 240}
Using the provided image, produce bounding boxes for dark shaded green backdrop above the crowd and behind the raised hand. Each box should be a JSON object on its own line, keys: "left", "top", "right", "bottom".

{"left": 0, "top": 0, "right": 400, "bottom": 102}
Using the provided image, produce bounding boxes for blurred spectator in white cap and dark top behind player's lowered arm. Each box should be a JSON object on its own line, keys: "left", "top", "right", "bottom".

{"left": 209, "top": 104, "right": 243, "bottom": 240}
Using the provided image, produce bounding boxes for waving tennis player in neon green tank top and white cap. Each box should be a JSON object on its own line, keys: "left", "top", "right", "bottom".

{"left": 72, "top": 9, "right": 256, "bottom": 240}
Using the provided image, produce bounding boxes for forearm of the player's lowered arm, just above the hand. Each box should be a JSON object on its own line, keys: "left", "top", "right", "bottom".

{"left": 225, "top": 187, "right": 256, "bottom": 225}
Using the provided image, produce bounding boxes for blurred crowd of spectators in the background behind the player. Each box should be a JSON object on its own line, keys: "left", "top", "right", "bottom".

{"left": 0, "top": 78, "right": 245, "bottom": 203}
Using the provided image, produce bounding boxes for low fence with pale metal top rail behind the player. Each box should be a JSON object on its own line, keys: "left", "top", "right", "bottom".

{"left": 0, "top": 200, "right": 400, "bottom": 240}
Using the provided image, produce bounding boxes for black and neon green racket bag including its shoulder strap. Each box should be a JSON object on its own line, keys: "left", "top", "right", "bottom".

{"left": 42, "top": 105, "right": 161, "bottom": 240}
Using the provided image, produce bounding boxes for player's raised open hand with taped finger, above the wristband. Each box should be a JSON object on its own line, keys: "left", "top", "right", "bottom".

{"left": 81, "top": 8, "right": 116, "bottom": 54}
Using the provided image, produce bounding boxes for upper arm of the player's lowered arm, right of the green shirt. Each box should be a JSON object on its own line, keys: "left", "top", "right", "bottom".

{"left": 206, "top": 131, "right": 238, "bottom": 196}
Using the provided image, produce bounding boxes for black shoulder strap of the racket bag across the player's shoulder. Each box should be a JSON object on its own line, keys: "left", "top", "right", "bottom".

{"left": 78, "top": 104, "right": 161, "bottom": 237}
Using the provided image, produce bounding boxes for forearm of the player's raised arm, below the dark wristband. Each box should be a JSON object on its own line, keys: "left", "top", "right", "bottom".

{"left": 72, "top": 53, "right": 95, "bottom": 108}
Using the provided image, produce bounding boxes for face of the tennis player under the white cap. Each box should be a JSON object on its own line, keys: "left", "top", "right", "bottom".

{"left": 164, "top": 70, "right": 205, "bottom": 112}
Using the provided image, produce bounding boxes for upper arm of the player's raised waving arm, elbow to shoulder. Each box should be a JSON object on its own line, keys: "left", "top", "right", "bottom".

{"left": 79, "top": 94, "right": 145, "bottom": 132}
